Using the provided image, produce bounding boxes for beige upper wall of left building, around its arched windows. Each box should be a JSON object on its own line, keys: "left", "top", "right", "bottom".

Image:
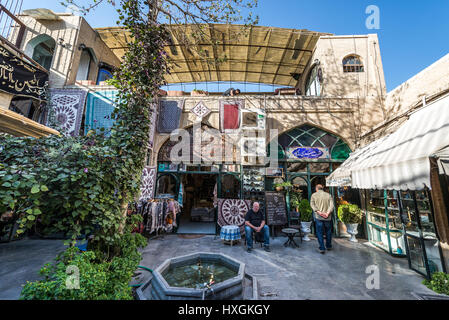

{"left": 12, "top": 14, "right": 120, "bottom": 88}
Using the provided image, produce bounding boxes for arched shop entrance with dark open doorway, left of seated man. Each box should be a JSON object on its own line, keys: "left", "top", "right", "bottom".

{"left": 156, "top": 125, "right": 242, "bottom": 234}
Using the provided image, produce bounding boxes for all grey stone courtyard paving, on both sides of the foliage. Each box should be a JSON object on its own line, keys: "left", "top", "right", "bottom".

{"left": 0, "top": 235, "right": 433, "bottom": 300}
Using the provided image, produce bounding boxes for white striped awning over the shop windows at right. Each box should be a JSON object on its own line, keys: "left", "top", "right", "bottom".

{"left": 327, "top": 96, "right": 449, "bottom": 190}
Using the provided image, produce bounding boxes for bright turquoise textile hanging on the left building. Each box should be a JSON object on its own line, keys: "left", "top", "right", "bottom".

{"left": 84, "top": 90, "right": 118, "bottom": 135}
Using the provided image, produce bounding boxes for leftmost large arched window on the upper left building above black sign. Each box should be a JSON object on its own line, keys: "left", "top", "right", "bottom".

{"left": 25, "top": 34, "right": 56, "bottom": 70}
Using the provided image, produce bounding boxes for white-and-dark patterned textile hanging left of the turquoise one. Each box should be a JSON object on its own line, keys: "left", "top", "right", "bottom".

{"left": 47, "top": 89, "right": 87, "bottom": 137}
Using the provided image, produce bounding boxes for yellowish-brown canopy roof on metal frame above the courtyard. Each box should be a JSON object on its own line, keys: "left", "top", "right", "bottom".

{"left": 96, "top": 24, "right": 329, "bottom": 87}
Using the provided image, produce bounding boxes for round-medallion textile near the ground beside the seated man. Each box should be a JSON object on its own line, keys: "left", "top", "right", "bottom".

{"left": 218, "top": 199, "right": 251, "bottom": 234}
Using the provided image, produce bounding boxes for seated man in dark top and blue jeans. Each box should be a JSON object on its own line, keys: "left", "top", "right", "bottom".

{"left": 245, "top": 202, "right": 270, "bottom": 252}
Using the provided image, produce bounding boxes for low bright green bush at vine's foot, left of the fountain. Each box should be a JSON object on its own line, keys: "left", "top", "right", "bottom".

{"left": 20, "top": 233, "right": 146, "bottom": 300}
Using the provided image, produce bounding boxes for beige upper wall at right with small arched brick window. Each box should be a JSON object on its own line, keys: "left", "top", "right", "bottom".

{"left": 300, "top": 34, "right": 386, "bottom": 132}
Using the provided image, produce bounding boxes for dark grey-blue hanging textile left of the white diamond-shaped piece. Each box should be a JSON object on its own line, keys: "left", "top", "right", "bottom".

{"left": 157, "top": 100, "right": 184, "bottom": 133}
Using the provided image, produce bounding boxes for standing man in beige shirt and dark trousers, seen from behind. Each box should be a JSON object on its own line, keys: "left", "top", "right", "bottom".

{"left": 310, "top": 184, "right": 334, "bottom": 254}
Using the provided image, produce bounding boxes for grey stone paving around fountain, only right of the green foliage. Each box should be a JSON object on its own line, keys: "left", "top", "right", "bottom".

{"left": 139, "top": 235, "right": 433, "bottom": 300}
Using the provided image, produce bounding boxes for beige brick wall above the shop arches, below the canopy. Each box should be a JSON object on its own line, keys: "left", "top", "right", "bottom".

{"left": 152, "top": 95, "right": 360, "bottom": 163}
